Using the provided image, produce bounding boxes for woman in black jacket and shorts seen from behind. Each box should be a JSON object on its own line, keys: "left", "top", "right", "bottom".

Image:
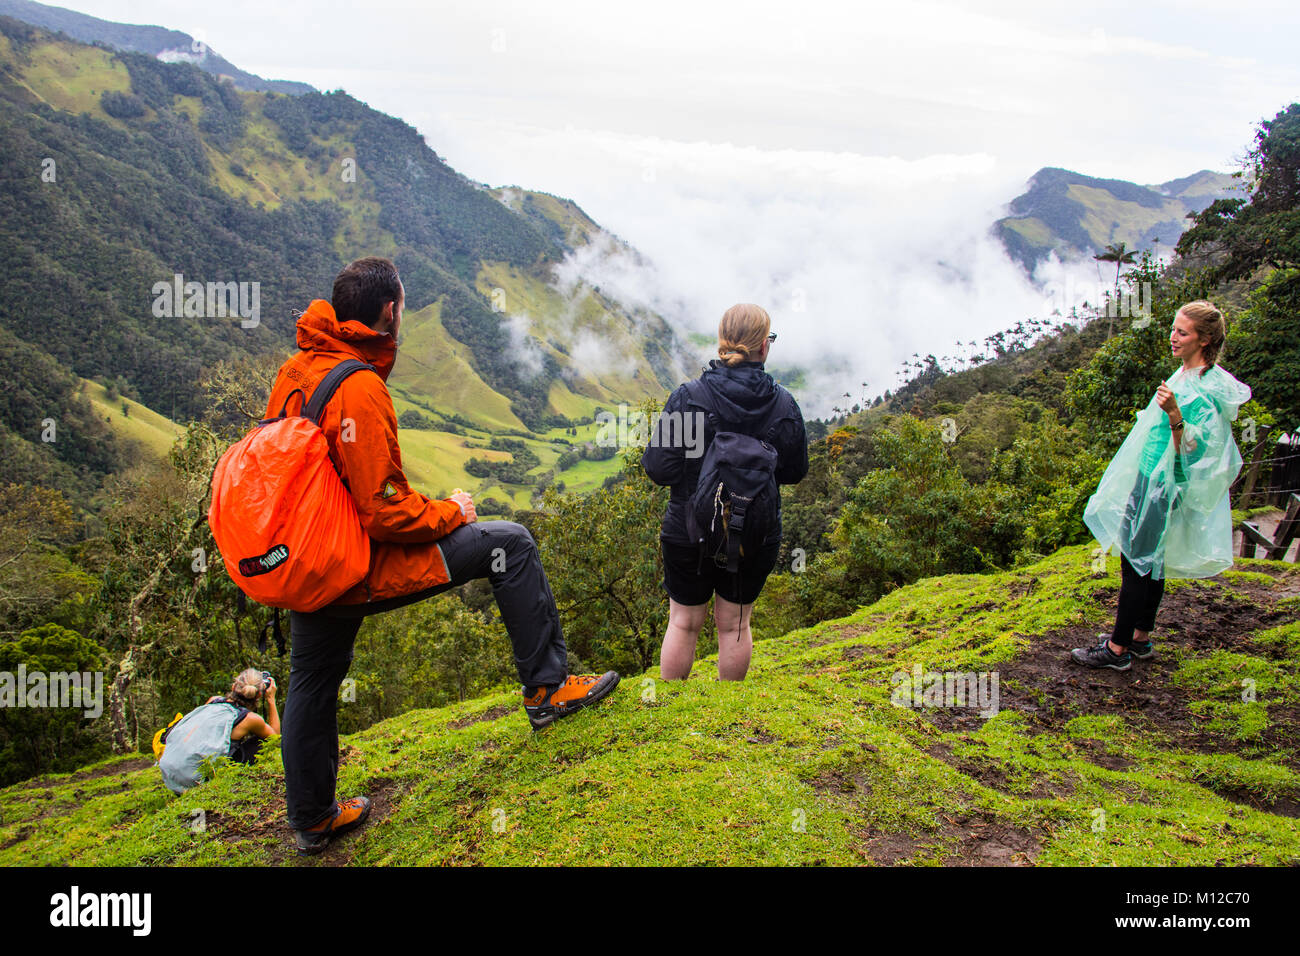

{"left": 641, "top": 304, "right": 809, "bottom": 680}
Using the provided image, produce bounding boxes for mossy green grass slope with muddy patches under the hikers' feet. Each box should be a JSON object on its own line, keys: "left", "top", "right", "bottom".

{"left": 0, "top": 548, "right": 1300, "bottom": 866}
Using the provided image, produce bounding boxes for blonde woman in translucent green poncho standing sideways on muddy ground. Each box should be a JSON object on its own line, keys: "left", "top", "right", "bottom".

{"left": 1070, "top": 300, "right": 1251, "bottom": 671}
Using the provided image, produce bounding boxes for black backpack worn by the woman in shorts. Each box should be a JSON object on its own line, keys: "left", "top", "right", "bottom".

{"left": 686, "top": 378, "right": 780, "bottom": 574}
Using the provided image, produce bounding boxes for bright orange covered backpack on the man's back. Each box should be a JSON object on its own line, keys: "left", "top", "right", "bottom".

{"left": 208, "top": 359, "right": 377, "bottom": 613}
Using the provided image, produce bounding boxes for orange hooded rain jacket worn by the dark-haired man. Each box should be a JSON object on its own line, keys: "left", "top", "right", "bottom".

{"left": 267, "top": 299, "right": 465, "bottom": 606}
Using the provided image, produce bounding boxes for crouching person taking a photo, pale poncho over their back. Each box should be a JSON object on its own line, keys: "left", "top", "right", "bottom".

{"left": 159, "top": 667, "right": 280, "bottom": 793}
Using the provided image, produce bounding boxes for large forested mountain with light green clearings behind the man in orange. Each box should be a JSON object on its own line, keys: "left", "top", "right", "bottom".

{"left": 0, "top": 18, "right": 692, "bottom": 502}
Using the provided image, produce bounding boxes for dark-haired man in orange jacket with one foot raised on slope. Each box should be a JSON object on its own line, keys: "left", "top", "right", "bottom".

{"left": 267, "top": 258, "right": 619, "bottom": 855}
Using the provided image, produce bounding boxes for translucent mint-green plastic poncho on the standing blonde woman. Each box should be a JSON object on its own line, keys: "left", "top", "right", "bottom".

{"left": 1083, "top": 365, "right": 1251, "bottom": 578}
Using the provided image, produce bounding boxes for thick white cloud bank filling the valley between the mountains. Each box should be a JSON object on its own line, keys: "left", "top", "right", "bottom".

{"left": 501, "top": 129, "right": 1071, "bottom": 415}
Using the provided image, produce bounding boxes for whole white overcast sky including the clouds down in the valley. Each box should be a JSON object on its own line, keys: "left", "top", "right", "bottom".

{"left": 50, "top": 0, "right": 1300, "bottom": 412}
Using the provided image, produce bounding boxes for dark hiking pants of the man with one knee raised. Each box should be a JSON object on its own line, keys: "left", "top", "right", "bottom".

{"left": 281, "top": 522, "right": 568, "bottom": 830}
